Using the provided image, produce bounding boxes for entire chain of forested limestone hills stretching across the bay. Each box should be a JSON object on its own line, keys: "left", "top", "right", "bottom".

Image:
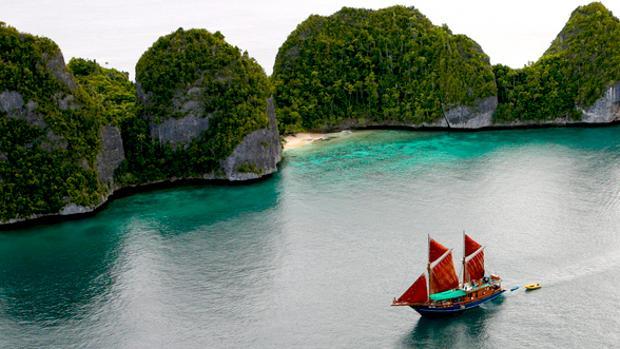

{"left": 0, "top": 2, "right": 620, "bottom": 225}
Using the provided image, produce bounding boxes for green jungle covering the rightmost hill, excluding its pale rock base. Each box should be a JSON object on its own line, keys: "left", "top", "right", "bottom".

{"left": 493, "top": 2, "right": 620, "bottom": 122}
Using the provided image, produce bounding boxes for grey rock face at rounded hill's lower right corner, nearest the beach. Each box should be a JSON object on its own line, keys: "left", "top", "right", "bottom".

{"left": 221, "top": 98, "right": 282, "bottom": 181}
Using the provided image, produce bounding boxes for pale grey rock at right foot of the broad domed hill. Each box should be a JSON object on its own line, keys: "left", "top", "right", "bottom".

{"left": 444, "top": 96, "right": 497, "bottom": 129}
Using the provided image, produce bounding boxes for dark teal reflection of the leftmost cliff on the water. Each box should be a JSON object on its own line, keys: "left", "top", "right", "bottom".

{"left": 0, "top": 221, "right": 121, "bottom": 322}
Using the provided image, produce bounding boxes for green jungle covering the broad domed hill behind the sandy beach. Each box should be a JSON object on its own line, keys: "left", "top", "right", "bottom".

{"left": 273, "top": 6, "right": 497, "bottom": 133}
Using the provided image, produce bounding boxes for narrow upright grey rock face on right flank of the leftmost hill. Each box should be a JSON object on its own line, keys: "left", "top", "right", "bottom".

{"left": 96, "top": 125, "right": 125, "bottom": 186}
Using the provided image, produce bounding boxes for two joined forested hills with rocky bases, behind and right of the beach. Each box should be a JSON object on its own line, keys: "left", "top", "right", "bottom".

{"left": 272, "top": 2, "right": 620, "bottom": 133}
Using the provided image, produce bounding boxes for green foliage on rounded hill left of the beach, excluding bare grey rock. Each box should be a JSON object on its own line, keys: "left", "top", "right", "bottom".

{"left": 118, "top": 29, "right": 272, "bottom": 184}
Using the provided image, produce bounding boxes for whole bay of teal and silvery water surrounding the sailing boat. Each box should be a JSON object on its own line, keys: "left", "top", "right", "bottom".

{"left": 0, "top": 127, "right": 620, "bottom": 348}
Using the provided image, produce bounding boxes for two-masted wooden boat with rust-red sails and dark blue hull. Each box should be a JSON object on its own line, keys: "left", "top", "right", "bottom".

{"left": 392, "top": 233, "right": 506, "bottom": 317}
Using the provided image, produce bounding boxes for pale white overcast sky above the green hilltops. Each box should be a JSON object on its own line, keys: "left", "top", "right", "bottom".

{"left": 0, "top": 0, "right": 620, "bottom": 76}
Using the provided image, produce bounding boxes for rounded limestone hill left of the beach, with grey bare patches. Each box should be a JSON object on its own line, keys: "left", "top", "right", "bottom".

{"left": 120, "top": 29, "right": 281, "bottom": 185}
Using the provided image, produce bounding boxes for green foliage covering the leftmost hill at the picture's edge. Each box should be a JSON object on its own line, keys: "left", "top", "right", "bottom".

{"left": 0, "top": 22, "right": 104, "bottom": 220}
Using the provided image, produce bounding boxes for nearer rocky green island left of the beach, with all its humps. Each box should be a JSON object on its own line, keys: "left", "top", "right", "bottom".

{"left": 0, "top": 24, "right": 281, "bottom": 224}
